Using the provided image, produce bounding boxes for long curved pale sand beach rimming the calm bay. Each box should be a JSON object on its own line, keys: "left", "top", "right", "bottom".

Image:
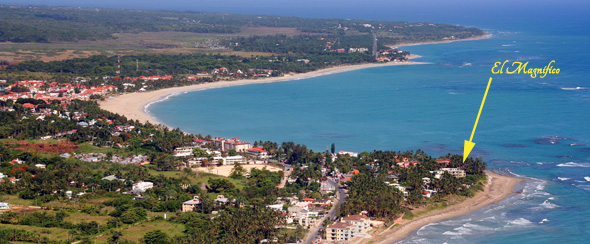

{"left": 99, "top": 54, "right": 428, "bottom": 124}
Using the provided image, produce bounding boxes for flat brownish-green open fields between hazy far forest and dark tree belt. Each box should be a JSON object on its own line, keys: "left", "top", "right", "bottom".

{"left": 0, "top": 27, "right": 303, "bottom": 62}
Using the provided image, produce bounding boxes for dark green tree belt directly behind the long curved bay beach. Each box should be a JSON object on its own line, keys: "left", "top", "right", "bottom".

{"left": 6, "top": 53, "right": 373, "bottom": 78}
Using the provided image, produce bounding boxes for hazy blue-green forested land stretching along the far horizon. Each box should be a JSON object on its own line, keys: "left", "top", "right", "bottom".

{"left": 0, "top": 5, "right": 483, "bottom": 44}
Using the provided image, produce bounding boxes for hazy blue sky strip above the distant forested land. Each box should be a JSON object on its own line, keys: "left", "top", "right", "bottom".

{"left": 0, "top": 0, "right": 590, "bottom": 24}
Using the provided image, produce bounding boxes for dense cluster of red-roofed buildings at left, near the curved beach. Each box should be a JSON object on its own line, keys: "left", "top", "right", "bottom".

{"left": 0, "top": 80, "right": 117, "bottom": 102}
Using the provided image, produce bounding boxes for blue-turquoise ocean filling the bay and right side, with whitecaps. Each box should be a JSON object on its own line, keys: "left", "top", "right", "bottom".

{"left": 148, "top": 4, "right": 590, "bottom": 243}
